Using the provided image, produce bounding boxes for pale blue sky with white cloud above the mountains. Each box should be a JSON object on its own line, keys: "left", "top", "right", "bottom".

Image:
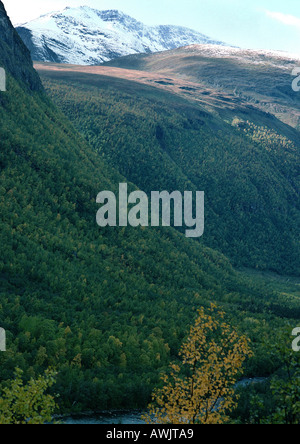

{"left": 4, "top": 0, "right": 300, "bottom": 55}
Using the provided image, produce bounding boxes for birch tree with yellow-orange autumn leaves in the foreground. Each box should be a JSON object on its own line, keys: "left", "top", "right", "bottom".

{"left": 143, "top": 304, "right": 252, "bottom": 424}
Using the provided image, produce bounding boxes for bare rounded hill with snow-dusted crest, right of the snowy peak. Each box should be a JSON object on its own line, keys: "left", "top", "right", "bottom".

{"left": 108, "top": 45, "right": 300, "bottom": 129}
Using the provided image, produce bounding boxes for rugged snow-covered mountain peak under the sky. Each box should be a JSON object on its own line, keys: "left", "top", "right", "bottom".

{"left": 16, "top": 6, "right": 223, "bottom": 65}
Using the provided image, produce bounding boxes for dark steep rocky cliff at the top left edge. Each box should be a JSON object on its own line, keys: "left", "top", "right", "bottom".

{"left": 0, "top": 1, "right": 43, "bottom": 91}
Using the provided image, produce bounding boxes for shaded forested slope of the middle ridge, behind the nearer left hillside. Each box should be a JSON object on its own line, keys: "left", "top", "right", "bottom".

{"left": 41, "top": 69, "right": 300, "bottom": 275}
